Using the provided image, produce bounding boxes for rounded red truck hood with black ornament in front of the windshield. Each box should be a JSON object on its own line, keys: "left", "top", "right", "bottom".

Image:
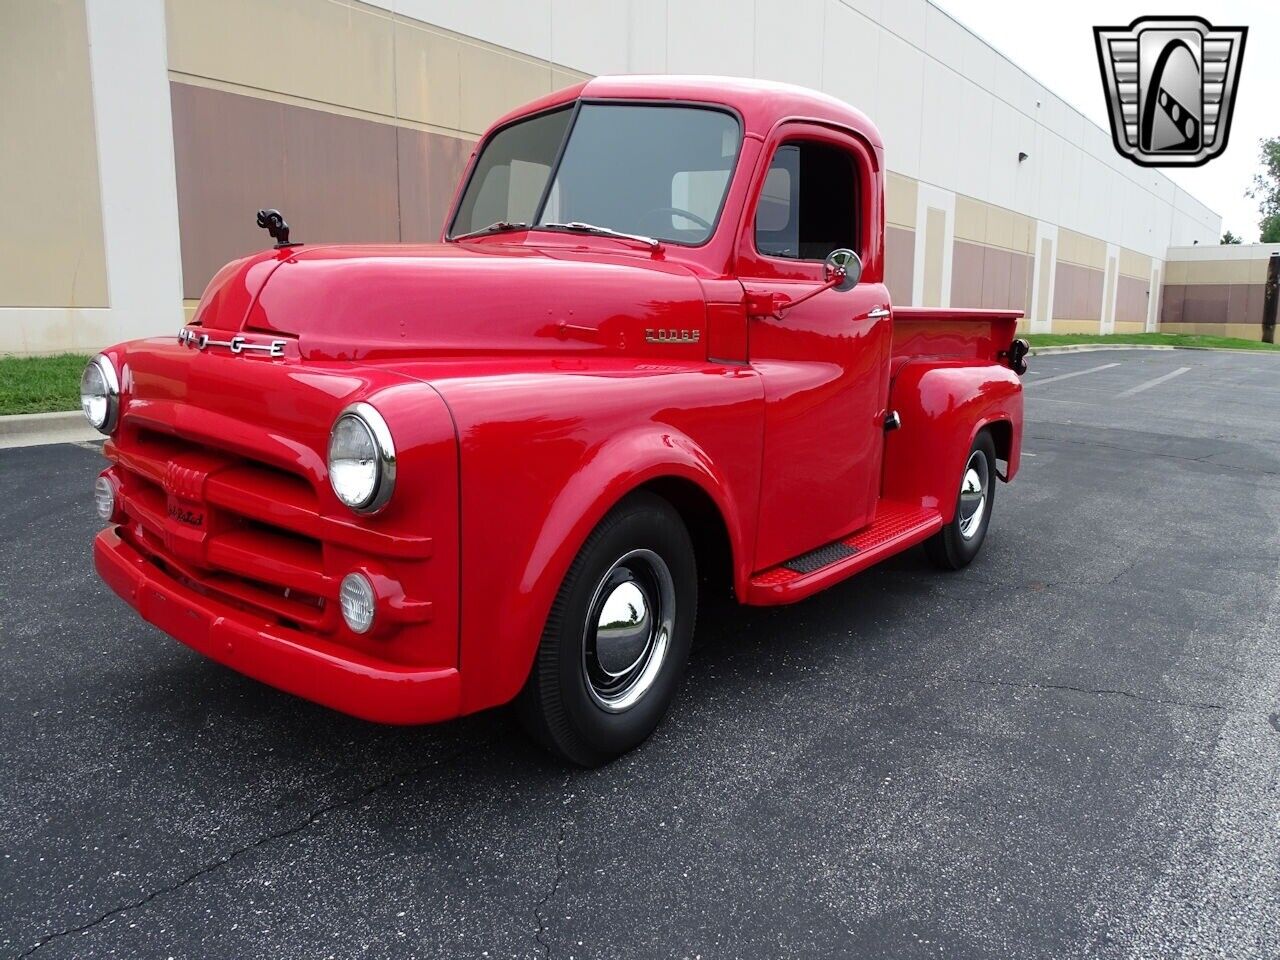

{"left": 193, "top": 243, "right": 707, "bottom": 360}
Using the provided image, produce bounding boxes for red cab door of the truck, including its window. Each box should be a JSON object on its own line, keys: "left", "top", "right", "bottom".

{"left": 739, "top": 124, "right": 891, "bottom": 570}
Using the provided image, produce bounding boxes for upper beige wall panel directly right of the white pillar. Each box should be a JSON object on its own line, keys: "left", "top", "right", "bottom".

{"left": 166, "top": 0, "right": 396, "bottom": 116}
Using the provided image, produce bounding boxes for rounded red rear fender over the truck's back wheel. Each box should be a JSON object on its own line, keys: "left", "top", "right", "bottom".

{"left": 882, "top": 360, "right": 1023, "bottom": 522}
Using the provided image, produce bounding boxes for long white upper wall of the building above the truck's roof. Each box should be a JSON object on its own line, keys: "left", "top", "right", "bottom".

{"left": 371, "top": 0, "right": 1220, "bottom": 257}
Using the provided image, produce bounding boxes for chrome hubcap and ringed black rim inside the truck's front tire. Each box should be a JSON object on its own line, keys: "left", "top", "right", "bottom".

{"left": 582, "top": 550, "right": 676, "bottom": 713}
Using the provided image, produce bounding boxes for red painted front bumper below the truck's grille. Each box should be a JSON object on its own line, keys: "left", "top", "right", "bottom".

{"left": 93, "top": 527, "right": 462, "bottom": 723}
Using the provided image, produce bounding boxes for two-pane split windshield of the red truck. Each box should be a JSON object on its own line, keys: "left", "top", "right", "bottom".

{"left": 449, "top": 102, "right": 741, "bottom": 244}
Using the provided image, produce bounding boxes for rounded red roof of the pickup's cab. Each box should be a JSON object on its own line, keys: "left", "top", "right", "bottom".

{"left": 490, "top": 74, "right": 883, "bottom": 150}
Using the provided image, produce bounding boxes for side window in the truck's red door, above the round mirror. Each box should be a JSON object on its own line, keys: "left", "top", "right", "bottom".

{"left": 755, "top": 141, "right": 859, "bottom": 260}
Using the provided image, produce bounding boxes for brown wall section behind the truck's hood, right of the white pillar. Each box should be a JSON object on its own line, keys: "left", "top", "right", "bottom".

{"left": 170, "top": 82, "right": 471, "bottom": 298}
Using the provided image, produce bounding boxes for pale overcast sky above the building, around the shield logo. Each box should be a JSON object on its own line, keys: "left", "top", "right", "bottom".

{"left": 931, "top": 0, "right": 1280, "bottom": 243}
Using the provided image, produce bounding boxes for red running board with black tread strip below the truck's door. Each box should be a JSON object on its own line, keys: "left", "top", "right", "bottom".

{"left": 746, "top": 500, "right": 942, "bottom": 605}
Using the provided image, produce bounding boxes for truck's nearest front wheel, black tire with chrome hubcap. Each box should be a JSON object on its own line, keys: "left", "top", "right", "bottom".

{"left": 517, "top": 492, "right": 698, "bottom": 767}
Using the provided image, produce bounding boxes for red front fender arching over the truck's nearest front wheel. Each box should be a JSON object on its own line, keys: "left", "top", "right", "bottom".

{"left": 438, "top": 365, "right": 763, "bottom": 712}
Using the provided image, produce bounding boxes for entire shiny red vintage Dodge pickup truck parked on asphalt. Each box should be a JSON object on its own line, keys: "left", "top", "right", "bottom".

{"left": 81, "top": 77, "right": 1025, "bottom": 764}
